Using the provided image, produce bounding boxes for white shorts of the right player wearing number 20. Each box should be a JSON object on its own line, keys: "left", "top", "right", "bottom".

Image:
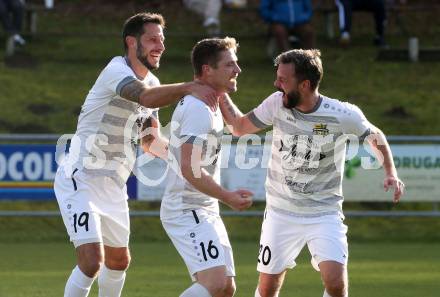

{"left": 257, "top": 210, "right": 348, "bottom": 274}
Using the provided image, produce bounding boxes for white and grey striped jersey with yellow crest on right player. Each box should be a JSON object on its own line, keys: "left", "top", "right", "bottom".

{"left": 250, "top": 92, "right": 373, "bottom": 217}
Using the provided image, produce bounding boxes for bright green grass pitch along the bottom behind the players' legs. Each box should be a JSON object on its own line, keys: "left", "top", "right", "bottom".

{"left": 0, "top": 241, "right": 440, "bottom": 297}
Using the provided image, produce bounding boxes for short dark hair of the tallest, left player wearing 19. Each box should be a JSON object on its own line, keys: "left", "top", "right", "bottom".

{"left": 122, "top": 12, "right": 165, "bottom": 51}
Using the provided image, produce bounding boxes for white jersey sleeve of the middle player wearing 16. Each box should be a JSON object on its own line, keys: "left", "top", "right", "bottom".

{"left": 180, "top": 100, "right": 212, "bottom": 145}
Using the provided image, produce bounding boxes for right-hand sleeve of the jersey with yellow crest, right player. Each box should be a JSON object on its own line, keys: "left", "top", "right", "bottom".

{"left": 343, "top": 103, "right": 374, "bottom": 141}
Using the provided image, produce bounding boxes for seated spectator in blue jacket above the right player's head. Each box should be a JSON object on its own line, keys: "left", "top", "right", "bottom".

{"left": 260, "top": 0, "right": 315, "bottom": 56}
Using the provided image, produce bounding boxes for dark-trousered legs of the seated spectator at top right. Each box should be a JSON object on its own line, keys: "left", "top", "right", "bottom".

{"left": 335, "top": 0, "right": 386, "bottom": 47}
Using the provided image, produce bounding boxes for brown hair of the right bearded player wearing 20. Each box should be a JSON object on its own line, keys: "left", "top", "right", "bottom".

{"left": 275, "top": 49, "right": 324, "bottom": 91}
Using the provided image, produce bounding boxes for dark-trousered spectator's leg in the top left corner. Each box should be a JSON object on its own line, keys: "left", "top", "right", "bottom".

{"left": 0, "top": 0, "right": 26, "bottom": 45}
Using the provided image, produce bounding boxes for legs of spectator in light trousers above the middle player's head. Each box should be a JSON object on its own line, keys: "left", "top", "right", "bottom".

{"left": 183, "top": 0, "right": 222, "bottom": 37}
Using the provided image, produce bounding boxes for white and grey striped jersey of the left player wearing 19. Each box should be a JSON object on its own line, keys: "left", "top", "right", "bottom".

{"left": 65, "top": 57, "right": 160, "bottom": 187}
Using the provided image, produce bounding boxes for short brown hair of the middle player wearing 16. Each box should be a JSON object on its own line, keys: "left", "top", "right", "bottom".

{"left": 191, "top": 37, "right": 238, "bottom": 76}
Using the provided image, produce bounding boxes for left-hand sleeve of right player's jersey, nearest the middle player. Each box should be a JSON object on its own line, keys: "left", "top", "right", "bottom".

{"left": 249, "top": 92, "right": 283, "bottom": 129}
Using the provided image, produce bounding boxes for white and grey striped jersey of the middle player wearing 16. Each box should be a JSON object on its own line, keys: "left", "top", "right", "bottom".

{"left": 160, "top": 95, "right": 224, "bottom": 219}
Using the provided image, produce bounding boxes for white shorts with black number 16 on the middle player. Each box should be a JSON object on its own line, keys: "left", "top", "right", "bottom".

{"left": 162, "top": 210, "right": 235, "bottom": 281}
